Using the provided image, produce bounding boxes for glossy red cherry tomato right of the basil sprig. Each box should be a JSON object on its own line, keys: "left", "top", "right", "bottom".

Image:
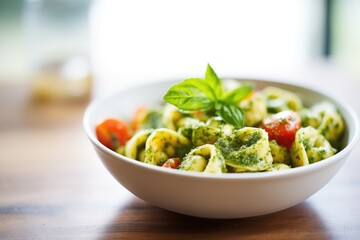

{"left": 262, "top": 110, "right": 301, "bottom": 148}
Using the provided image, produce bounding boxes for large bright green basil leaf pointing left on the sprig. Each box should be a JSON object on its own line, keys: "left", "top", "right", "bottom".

{"left": 164, "top": 78, "right": 215, "bottom": 111}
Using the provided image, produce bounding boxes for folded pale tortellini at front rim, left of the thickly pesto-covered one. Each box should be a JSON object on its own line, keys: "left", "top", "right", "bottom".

{"left": 179, "top": 144, "right": 227, "bottom": 173}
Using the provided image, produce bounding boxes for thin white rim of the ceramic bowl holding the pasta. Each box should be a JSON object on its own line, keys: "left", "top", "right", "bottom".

{"left": 82, "top": 77, "right": 359, "bottom": 180}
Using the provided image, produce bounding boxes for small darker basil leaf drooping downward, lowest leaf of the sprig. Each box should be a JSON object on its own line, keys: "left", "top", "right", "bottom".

{"left": 216, "top": 102, "right": 245, "bottom": 128}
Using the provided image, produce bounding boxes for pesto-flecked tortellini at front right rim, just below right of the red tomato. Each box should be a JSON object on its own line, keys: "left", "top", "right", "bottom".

{"left": 290, "top": 126, "right": 336, "bottom": 167}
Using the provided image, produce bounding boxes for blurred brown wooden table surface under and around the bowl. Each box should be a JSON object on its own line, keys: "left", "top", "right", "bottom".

{"left": 0, "top": 62, "right": 360, "bottom": 239}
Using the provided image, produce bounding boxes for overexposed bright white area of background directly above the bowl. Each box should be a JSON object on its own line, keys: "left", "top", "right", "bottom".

{"left": 90, "top": 0, "right": 322, "bottom": 95}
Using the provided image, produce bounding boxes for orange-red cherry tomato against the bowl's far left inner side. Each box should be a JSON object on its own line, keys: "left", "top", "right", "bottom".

{"left": 95, "top": 118, "right": 131, "bottom": 150}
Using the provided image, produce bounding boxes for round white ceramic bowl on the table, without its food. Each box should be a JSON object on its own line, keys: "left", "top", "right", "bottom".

{"left": 83, "top": 80, "right": 359, "bottom": 218}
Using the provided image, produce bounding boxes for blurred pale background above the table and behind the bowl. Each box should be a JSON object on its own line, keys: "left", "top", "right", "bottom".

{"left": 0, "top": 0, "right": 360, "bottom": 100}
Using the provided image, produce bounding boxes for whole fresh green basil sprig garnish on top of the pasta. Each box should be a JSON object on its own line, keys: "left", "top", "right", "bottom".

{"left": 164, "top": 64, "right": 253, "bottom": 128}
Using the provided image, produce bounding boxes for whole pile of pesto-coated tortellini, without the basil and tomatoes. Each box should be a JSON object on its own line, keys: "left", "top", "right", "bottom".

{"left": 117, "top": 84, "right": 344, "bottom": 173}
